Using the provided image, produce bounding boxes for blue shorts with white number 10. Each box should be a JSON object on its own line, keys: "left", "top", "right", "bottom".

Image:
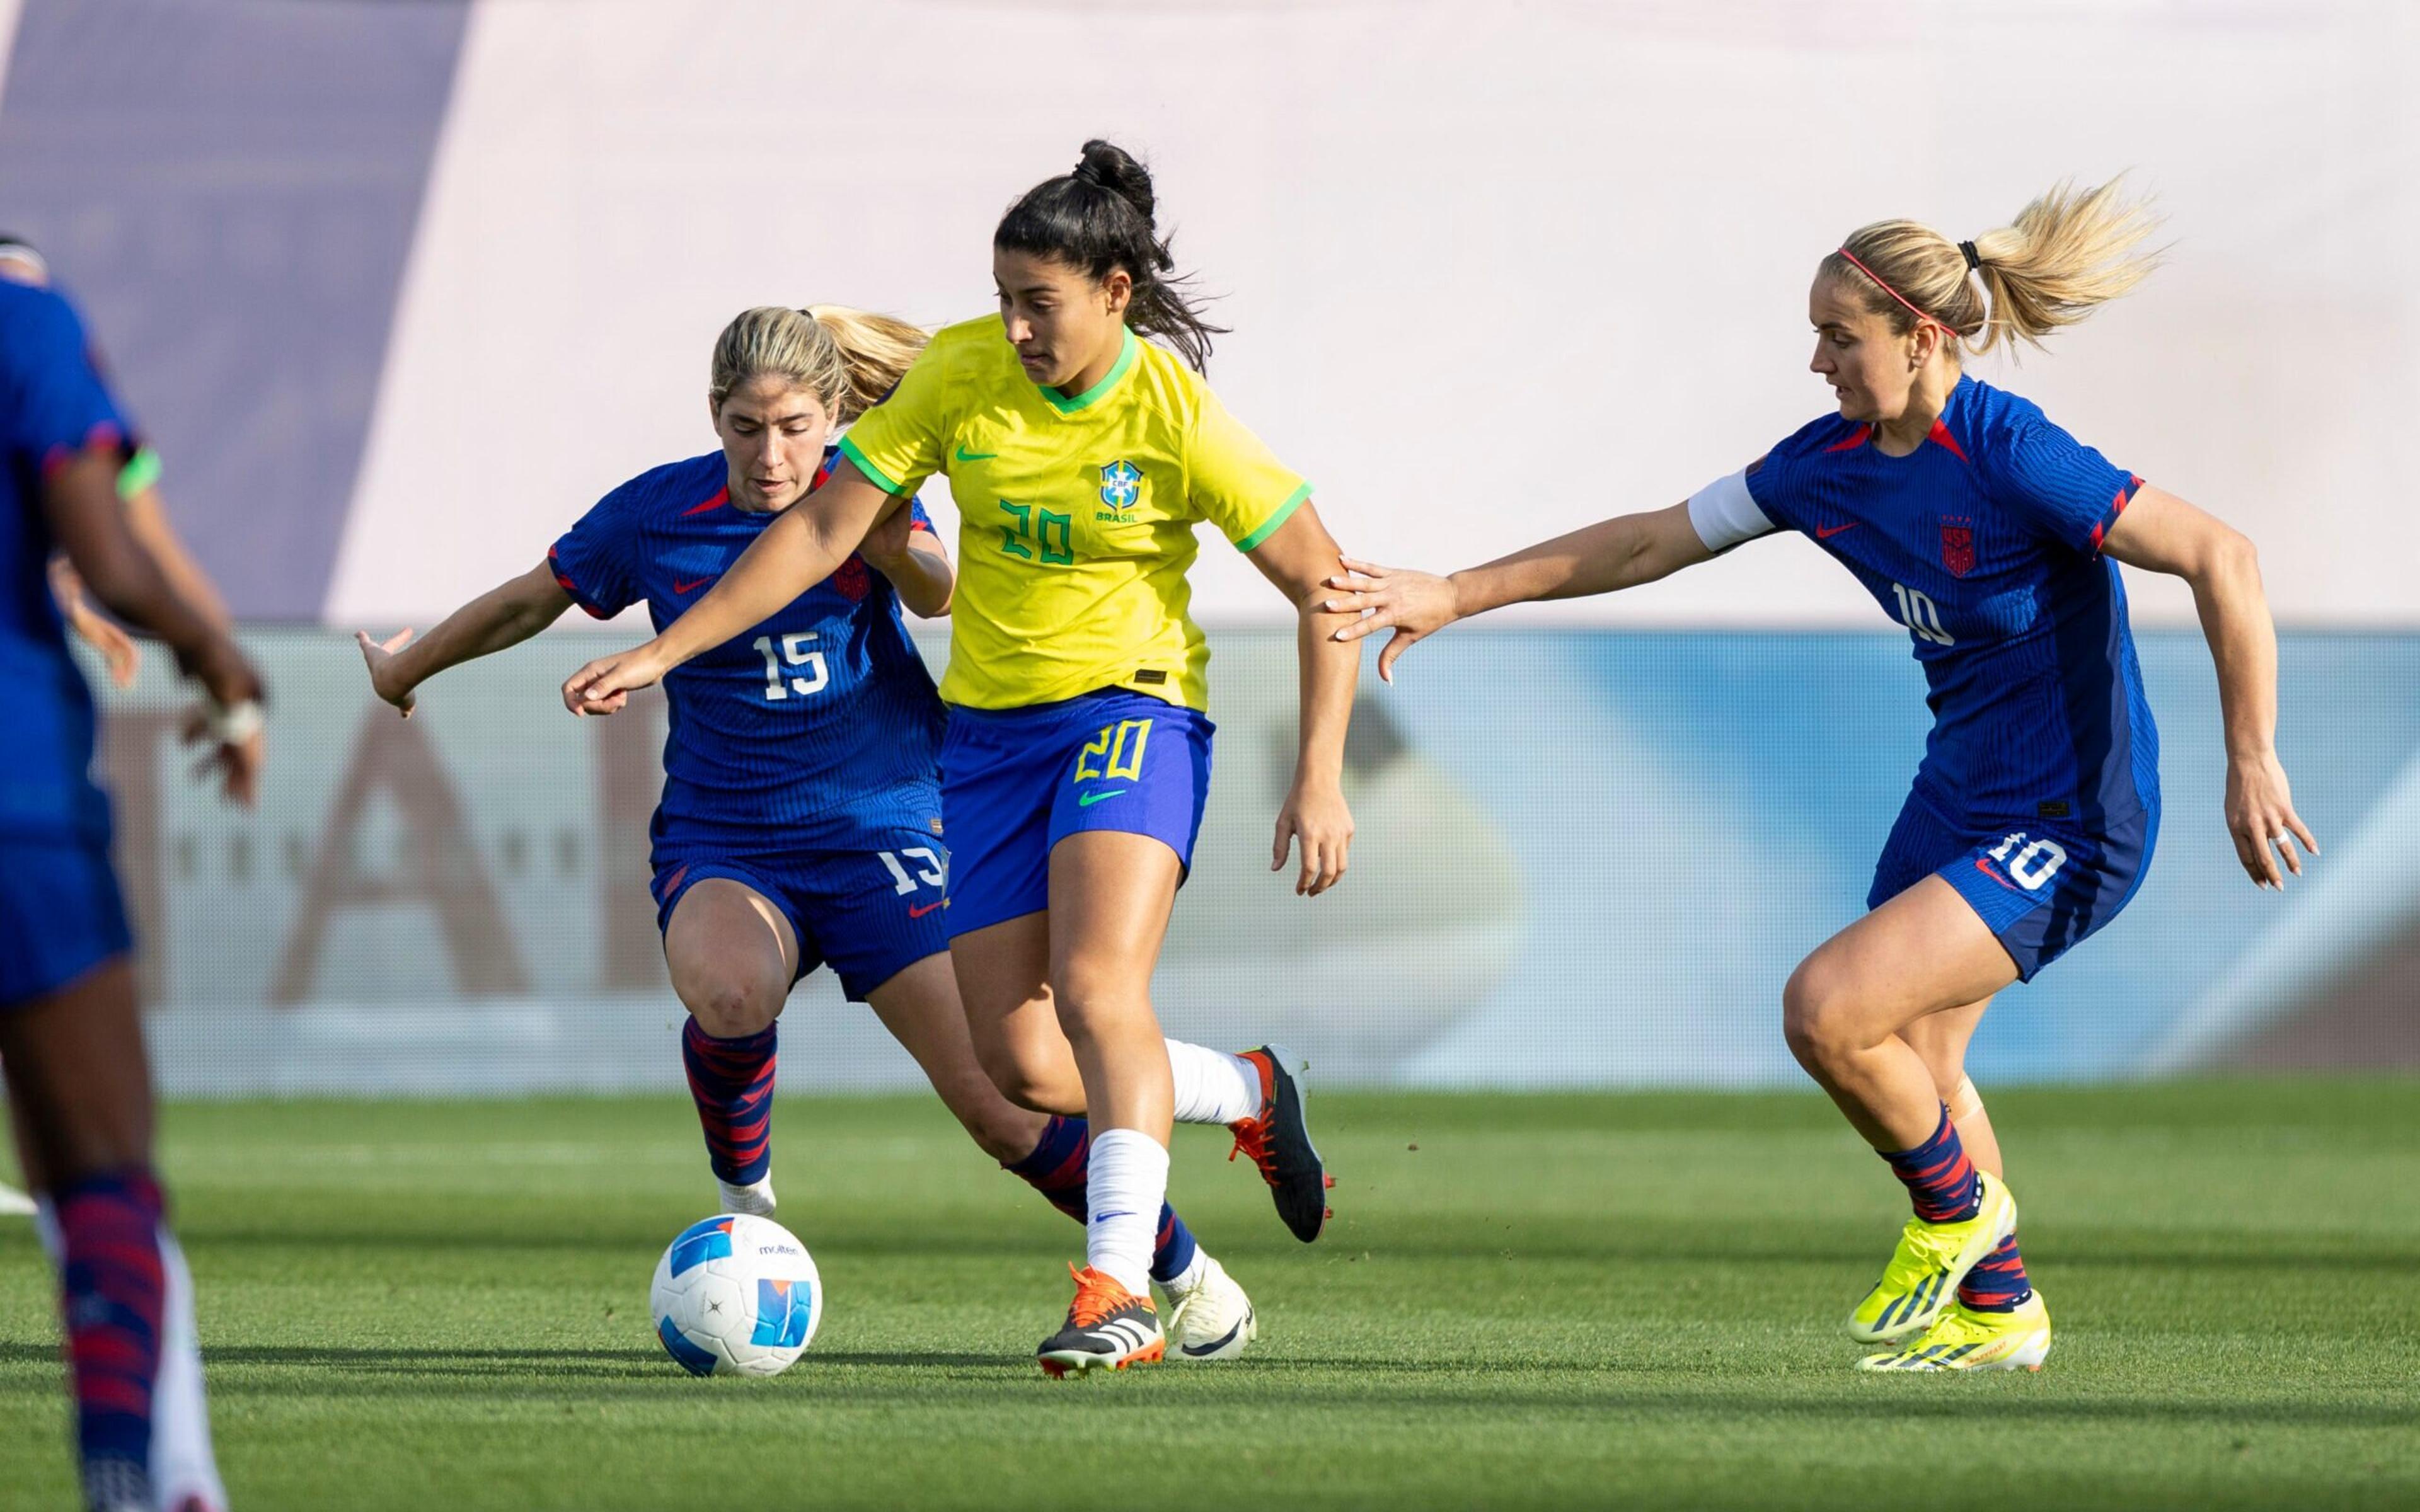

{"left": 1866, "top": 794, "right": 2158, "bottom": 982}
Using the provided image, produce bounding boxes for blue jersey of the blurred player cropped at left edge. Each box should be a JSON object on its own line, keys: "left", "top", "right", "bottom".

{"left": 0, "top": 280, "right": 129, "bottom": 839}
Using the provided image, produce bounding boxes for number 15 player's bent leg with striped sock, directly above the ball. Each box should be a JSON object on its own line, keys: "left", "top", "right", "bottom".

{"left": 663, "top": 876, "right": 798, "bottom": 1217}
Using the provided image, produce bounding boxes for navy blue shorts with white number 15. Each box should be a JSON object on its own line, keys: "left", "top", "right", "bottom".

{"left": 654, "top": 820, "right": 948, "bottom": 1002}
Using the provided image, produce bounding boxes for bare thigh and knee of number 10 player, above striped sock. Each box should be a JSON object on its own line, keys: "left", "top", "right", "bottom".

{"left": 1781, "top": 876, "right": 2016, "bottom": 1152}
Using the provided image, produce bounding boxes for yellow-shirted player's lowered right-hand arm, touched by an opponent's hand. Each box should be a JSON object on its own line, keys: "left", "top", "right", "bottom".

{"left": 1251, "top": 498, "right": 1360, "bottom": 898}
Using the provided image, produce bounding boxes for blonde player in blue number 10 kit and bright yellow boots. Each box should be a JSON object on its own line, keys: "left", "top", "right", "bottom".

{"left": 1331, "top": 186, "right": 2319, "bottom": 1369}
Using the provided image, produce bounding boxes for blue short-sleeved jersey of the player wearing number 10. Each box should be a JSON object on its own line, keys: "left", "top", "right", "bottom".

{"left": 1745, "top": 377, "right": 2158, "bottom": 827}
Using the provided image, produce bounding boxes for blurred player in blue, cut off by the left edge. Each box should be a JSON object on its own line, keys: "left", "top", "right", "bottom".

{"left": 0, "top": 278, "right": 262, "bottom": 1512}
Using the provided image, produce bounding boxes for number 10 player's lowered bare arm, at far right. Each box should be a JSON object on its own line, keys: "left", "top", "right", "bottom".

{"left": 2100, "top": 484, "right": 2319, "bottom": 888}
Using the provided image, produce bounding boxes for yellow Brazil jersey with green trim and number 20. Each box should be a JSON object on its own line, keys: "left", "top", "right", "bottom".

{"left": 839, "top": 317, "right": 1311, "bottom": 709}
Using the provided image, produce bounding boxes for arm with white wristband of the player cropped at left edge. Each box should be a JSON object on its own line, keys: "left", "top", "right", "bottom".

{"left": 41, "top": 447, "right": 264, "bottom": 803}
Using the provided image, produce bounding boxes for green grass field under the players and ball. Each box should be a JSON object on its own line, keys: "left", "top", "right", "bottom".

{"left": 0, "top": 1081, "right": 2420, "bottom": 1512}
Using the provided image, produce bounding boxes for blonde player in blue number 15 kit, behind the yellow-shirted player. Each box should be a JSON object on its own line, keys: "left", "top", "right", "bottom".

{"left": 372, "top": 305, "right": 1256, "bottom": 1360}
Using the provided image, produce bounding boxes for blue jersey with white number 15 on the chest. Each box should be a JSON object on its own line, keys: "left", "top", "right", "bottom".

{"left": 547, "top": 452, "right": 942, "bottom": 849}
